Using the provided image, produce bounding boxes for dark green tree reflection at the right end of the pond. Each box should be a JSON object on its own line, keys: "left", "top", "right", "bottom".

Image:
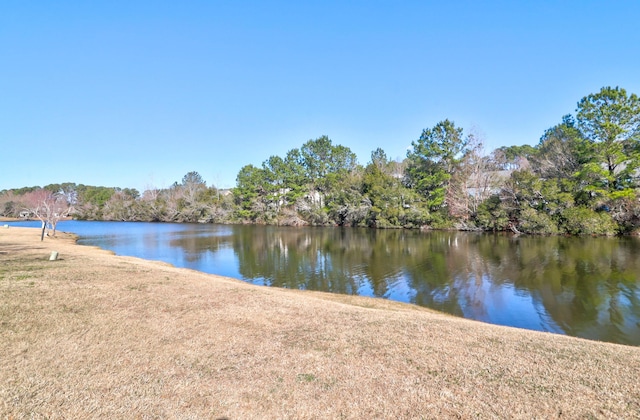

{"left": 470, "top": 237, "right": 640, "bottom": 344}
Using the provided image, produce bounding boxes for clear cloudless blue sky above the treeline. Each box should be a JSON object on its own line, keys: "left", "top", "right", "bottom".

{"left": 0, "top": 0, "right": 640, "bottom": 191}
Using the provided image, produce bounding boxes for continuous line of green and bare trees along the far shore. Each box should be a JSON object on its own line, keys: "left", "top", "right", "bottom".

{"left": 0, "top": 87, "right": 640, "bottom": 235}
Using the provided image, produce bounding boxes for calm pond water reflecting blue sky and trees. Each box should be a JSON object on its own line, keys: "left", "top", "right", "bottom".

{"left": 6, "top": 221, "right": 640, "bottom": 345}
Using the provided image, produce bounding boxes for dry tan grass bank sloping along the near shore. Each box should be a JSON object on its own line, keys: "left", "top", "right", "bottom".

{"left": 0, "top": 228, "right": 640, "bottom": 419}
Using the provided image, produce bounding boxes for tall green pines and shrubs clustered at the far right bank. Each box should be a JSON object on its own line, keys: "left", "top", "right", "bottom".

{"left": 472, "top": 87, "right": 640, "bottom": 235}
